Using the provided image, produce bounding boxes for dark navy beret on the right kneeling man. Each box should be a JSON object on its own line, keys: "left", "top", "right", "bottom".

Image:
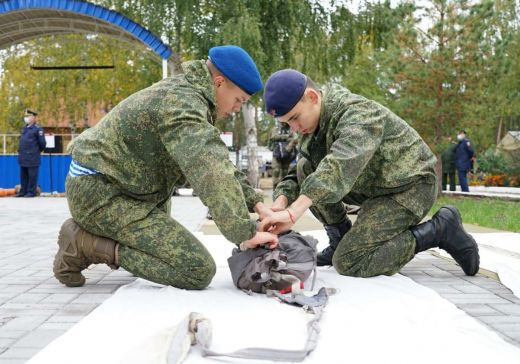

{"left": 264, "top": 68, "right": 307, "bottom": 117}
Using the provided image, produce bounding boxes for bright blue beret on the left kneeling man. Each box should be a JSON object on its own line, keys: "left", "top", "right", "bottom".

{"left": 209, "top": 45, "right": 263, "bottom": 95}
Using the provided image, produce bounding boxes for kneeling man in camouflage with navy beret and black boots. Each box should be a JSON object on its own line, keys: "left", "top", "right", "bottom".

{"left": 260, "top": 69, "right": 479, "bottom": 277}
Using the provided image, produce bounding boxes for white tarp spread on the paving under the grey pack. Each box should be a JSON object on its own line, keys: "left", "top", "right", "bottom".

{"left": 29, "top": 232, "right": 520, "bottom": 364}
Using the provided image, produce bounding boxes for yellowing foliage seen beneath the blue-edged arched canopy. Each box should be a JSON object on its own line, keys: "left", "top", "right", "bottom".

{"left": 0, "top": 35, "right": 160, "bottom": 138}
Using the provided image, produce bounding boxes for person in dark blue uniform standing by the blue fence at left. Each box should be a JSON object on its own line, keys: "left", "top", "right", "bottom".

{"left": 16, "top": 109, "right": 46, "bottom": 197}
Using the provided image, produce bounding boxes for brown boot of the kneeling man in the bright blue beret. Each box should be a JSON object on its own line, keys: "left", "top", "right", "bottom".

{"left": 53, "top": 219, "right": 118, "bottom": 287}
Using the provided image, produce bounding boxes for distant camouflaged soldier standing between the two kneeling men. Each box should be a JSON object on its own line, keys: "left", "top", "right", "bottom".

{"left": 269, "top": 122, "right": 298, "bottom": 189}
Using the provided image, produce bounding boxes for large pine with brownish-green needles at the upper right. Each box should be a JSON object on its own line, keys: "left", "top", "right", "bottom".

{"left": 383, "top": 0, "right": 518, "bottom": 150}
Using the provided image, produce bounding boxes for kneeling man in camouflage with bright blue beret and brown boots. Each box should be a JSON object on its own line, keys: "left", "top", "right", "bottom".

{"left": 54, "top": 46, "right": 277, "bottom": 289}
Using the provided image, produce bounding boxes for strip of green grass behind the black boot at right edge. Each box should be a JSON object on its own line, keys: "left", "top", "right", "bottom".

{"left": 430, "top": 196, "right": 520, "bottom": 233}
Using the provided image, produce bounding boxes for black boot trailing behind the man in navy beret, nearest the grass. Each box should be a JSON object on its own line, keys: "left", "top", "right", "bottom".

{"left": 410, "top": 206, "right": 480, "bottom": 276}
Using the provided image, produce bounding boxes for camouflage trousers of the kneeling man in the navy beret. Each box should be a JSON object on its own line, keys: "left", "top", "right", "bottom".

{"left": 297, "top": 158, "right": 437, "bottom": 277}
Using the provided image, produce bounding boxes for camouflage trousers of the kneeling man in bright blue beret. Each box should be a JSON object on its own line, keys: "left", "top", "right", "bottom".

{"left": 66, "top": 175, "right": 216, "bottom": 289}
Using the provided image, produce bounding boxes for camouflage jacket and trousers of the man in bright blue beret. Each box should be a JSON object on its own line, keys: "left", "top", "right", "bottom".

{"left": 66, "top": 61, "right": 263, "bottom": 289}
